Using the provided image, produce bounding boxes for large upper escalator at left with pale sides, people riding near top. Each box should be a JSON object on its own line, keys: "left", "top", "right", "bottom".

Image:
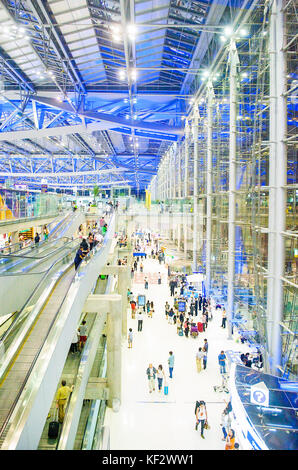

{"left": 0, "top": 213, "right": 114, "bottom": 449}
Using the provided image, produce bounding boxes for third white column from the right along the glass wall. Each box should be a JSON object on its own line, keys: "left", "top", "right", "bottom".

{"left": 206, "top": 80, "right": 214, "bottom": 296}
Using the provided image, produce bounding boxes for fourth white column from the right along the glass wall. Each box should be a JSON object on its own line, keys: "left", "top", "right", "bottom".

{"left": 192, "top": 102, "right": 199, "bottom": 271}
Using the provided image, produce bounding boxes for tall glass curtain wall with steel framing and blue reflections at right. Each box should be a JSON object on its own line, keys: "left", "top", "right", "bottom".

{"left": 151, "top": 0, "right": 298, "bottom": 378}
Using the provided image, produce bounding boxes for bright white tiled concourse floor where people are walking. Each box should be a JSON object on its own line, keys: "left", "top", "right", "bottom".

{"left": 105, "top": 255, "right": 246, "bottom": 450}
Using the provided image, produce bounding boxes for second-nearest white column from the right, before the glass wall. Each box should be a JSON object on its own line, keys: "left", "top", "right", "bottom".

{"left": 227, "top": 39, "right": 239, "bottom": 339}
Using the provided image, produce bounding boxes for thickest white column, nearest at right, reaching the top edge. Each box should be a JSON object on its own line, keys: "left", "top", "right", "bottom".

{"left": 266, "top": 0, "right": 287, "bottom": 374}
